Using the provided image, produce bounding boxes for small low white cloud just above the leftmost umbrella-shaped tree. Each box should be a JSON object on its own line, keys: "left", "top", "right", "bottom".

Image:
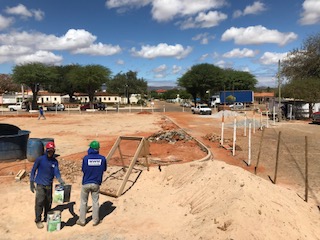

{"left": 15, "top": 51, "right": 63, "bottom": 65}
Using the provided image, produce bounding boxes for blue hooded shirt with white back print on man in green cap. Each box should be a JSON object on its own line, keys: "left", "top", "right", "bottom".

{"left": 82, "top": 148, "right": 107, "bottom": 185}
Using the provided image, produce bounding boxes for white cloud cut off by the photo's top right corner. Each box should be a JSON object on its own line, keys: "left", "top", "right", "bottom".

{"left": 300, "top": 0, "right": 320, "bottom": 25}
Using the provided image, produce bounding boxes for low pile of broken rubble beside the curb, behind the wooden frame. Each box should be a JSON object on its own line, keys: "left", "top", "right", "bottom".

{"left": 147, "top": 129, "right": 194, "bottom": 143}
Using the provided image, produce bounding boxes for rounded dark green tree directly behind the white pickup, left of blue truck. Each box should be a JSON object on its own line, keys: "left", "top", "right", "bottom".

{"left": 177, "top": 63, "right": 224, "bottom": 103}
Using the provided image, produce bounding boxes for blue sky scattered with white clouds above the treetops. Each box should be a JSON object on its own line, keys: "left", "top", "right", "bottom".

{"left": 0, "top": 0, "right": 320, "bottom": 87}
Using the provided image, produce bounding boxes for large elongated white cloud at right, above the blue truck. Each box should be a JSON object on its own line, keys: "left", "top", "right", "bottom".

{"left": 221, "top": 25, "right": 298, "bottom": 46}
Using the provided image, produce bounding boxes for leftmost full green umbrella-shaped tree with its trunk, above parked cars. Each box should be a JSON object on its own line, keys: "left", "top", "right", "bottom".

{"left": 12, "top": 62, "right": 57, "bottom": 109}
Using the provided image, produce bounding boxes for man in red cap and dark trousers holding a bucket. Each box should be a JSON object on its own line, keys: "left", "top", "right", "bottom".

{"left": 30, "top": 142, "right": 64, "bottom": 228}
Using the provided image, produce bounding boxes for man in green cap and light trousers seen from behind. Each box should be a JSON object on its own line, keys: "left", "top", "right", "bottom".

{"left": 77, "top": 141, "right": 107, "bottom": 227}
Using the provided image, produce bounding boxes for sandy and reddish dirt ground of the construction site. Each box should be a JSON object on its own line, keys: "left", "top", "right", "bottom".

{"left": 0, "top": 107, "right": 320, "bottom": 239}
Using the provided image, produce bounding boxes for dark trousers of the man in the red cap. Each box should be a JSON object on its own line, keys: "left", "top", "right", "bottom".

{"left": 35, "top": 184, "right": 52, "bottom": 222}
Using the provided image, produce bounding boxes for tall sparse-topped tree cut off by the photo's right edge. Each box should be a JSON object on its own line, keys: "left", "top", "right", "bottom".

{"left": 281, "top": 33, "right": 320, "bottom": 117}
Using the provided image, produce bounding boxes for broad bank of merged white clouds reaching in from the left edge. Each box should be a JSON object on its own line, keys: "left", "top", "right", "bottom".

{"left": 0, "top": 29, "right": 122, "bottom": 64}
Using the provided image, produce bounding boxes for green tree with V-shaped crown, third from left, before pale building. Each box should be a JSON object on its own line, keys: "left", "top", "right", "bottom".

{"left": 68, "top": 65, "right": 111, "bottom": 104}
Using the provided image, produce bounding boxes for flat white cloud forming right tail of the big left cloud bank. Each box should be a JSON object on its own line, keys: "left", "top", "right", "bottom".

{"left": 72, "top": 43, "right": 121, "bottom": 56}
